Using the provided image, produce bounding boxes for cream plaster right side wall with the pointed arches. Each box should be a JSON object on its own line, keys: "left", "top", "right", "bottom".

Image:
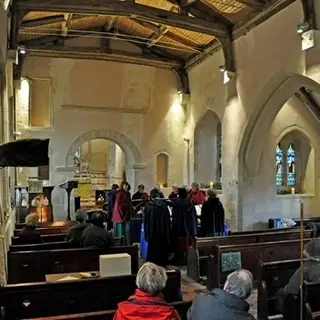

{"left": 185, "top": 1, "right": 320, "bottom": 229}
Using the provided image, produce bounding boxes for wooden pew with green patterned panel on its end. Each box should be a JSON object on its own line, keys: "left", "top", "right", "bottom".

{"left": 207, "top": 239, "right": 310, "bottom": 290}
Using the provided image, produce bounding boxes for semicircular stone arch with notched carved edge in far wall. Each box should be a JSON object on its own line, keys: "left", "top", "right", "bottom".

{"left": 65, "top": 128, "right": 142, "bottom": 167}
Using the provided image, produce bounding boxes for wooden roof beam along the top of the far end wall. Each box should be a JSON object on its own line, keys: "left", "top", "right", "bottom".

{"left": 27, "top": 46, "right": 181, "bottom": 69}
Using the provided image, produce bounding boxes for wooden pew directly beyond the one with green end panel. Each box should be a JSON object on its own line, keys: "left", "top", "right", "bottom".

{"left": 187, "top": 229, "right": 311, "bottom": 281}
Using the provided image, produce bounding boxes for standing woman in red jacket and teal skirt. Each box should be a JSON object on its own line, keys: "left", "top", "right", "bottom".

{"left": 112, "top": 182, "right": 132, "bottom": 245}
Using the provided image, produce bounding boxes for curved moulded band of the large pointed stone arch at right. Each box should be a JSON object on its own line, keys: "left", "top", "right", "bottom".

{"left": 239, "top": 73, "right": 320, "bottom": 176}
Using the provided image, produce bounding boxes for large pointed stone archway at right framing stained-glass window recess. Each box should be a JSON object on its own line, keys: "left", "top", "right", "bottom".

{"left": 235, "top": 73, "right": 320, "bottom": 230}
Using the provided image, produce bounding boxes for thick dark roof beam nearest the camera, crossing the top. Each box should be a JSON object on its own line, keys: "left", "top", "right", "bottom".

{"left": 12, "top": 0, "right": 228, "bottom": 37}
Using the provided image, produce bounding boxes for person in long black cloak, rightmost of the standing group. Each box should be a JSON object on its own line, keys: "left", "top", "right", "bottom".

{"left": 200, "top": 189, "right": 224, "bottom": 237}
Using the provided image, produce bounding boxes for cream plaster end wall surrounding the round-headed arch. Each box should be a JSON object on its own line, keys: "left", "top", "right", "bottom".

{"left": 22, "top": 57, "right": 185, "bottom": 218}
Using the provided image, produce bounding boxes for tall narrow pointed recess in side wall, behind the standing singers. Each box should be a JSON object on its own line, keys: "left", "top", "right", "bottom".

{"left": 194, "top": 110, "right": 222, "bottom": 185}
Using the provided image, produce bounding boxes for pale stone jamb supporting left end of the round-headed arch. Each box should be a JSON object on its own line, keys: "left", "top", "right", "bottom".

{"left": 52, "top": 167, "right": 74, "bottom": 220}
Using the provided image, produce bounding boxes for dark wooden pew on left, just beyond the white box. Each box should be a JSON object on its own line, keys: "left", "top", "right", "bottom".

{"left": 8, "top": 246, "right": 139, "bottom": 284}
